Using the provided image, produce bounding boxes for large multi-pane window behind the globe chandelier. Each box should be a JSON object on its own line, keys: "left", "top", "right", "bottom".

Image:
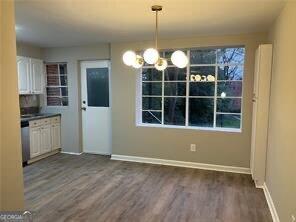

{"left": 137, "top": 47, "right": 245, "bottom": 131}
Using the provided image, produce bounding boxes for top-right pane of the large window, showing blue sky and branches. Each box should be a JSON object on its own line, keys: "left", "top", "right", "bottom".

{"left": 218, "top": 48, "right": 245, "bottom": 64}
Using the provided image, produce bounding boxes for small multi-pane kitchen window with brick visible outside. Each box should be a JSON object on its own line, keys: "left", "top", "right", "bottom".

{"left": 45, "top": 63, "right": 68, "bottom": 106}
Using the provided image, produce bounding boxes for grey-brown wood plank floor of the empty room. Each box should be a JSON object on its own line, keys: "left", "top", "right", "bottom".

{"left": 24, "top": 154, "right": 272, "bottom": 222}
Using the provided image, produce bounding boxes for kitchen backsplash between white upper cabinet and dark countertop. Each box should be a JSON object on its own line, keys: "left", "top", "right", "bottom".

{"left": 20, "top": 95, "right": 40, "bottom": 114}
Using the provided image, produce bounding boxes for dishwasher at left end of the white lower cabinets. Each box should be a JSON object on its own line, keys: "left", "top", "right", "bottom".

{"left": 21, "top": 121, "right": 30, "bottom": 164}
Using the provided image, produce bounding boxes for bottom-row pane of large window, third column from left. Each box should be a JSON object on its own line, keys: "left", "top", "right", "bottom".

{"left": 189, "top": 98, "right": 214, "bottom": 127}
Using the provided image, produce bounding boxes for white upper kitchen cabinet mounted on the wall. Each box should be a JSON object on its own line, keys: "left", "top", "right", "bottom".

{"left": 17, "top": 56, "right": 44, "bottom": 94}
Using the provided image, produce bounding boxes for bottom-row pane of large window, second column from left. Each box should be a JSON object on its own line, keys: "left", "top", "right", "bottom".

{"left": 164, "top": 98, "right": 186, "bottom": 126}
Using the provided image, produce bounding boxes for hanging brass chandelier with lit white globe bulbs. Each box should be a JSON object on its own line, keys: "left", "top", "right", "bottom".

{"left": 122, "top": 5, "right": 188, "bottom": 71}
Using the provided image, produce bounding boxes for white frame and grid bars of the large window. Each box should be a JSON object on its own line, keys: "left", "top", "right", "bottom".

{"left": 136, "top": 45, "right": 246, "bottom": 133}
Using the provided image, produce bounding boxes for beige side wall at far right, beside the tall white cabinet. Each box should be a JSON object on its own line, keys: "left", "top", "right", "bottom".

{"left": 266, "top": 2, "right": 296, "bottom": 221}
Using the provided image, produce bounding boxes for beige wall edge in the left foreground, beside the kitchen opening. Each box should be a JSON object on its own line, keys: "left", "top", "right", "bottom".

{"left": 0, "top": 1, "right": 24, "bottom": 211}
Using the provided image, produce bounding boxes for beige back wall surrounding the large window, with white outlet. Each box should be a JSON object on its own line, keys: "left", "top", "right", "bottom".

{"left": 111, "top": 34, "right": 267, "bottom": 167}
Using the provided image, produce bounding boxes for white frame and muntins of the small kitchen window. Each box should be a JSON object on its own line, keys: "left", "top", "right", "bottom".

{"left": 44, "top": 62, "right": 70, "bottom": 109}
